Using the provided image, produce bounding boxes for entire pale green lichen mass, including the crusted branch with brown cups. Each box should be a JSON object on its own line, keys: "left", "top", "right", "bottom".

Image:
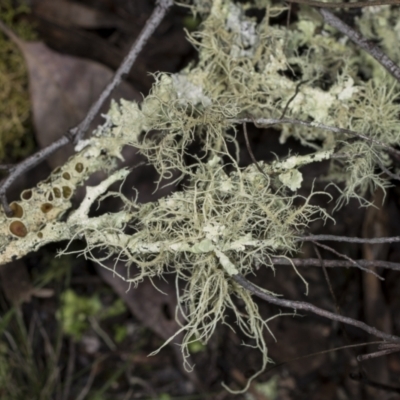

{"left": 0, "top": 0, "right": 400, "bottom": 390}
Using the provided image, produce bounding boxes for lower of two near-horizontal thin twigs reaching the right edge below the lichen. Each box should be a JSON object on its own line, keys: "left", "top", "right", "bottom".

{"left": 271, "top": 257, "right": 400, "bottom": 271}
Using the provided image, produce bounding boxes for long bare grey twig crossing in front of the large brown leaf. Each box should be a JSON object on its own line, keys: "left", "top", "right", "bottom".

{"left": 0, "top": 0, "right": 173, "bottom": 216}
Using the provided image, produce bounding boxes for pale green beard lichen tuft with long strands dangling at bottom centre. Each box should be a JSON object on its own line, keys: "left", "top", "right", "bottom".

{"left": 60, "top": 156, "right": 328, "bottom": 390}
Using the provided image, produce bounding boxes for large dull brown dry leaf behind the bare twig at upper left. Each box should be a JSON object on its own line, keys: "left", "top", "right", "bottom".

{"left": 2, "top": 21, "right": 141, "bottom": 168}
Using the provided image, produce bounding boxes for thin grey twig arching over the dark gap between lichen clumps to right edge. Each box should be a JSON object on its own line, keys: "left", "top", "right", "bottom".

{"left": 230, "top": 118, "right": 400, "bottom": 158}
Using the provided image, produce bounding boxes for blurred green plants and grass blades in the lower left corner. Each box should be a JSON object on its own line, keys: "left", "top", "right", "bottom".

{"left": 0, "top": 253, "right": 128, "bottom": 400}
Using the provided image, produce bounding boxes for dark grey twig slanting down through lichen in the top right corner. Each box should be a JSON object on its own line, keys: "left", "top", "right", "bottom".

{"left": 318, "top": 8, "right": 400, "bottom": 81}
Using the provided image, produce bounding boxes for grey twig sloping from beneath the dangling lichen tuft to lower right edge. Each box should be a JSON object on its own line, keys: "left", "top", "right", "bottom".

{"left": 232, "top": 274, "right": 400, "bottom": 343}
